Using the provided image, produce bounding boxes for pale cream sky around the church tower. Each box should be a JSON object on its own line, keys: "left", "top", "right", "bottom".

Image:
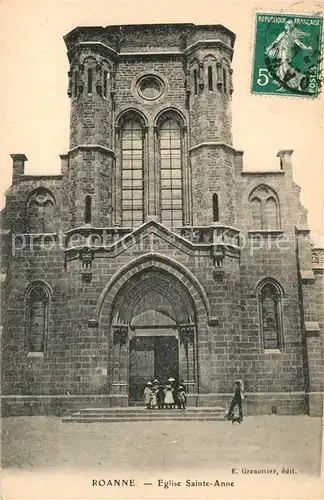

{"left": 0, "top": 0, "right": 324, "bottom": 243}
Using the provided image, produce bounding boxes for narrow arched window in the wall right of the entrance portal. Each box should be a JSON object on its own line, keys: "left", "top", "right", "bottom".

{"left": 258, "top": 280, "right": 283, "bottom": 350}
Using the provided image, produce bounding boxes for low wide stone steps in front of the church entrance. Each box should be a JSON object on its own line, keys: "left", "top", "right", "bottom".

{"left": 62, "top": 406, "right": 225, "bottom": 424}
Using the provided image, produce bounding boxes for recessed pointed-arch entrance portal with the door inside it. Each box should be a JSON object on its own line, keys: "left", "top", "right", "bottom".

{"left": 109, "top": 268, "right": 197, "bottom": 404}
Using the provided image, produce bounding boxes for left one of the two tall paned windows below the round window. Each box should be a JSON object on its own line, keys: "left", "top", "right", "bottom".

{"left": 121, "top": 119, "right": 143, "bottom": 227}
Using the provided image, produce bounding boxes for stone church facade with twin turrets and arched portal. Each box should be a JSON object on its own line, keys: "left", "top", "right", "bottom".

{"left": 2, "top": 24, "right": 324, "bottom": 415}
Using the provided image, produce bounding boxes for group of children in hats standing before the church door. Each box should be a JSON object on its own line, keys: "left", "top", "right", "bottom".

{"left": 144, "top": 378, "right": 187, "bottom": 410}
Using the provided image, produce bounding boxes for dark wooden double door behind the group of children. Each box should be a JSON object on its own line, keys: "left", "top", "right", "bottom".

{"left": 129, "top": 335, "right": 179, "bottom": 404}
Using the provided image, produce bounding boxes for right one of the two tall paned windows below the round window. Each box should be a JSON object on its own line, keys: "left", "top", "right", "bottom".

{"left": 160, "top": 119, "right": 182, "bottom": 227}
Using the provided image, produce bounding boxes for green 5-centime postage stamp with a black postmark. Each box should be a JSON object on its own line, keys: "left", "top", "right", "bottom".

{"left": 252, "top": 14, "right": 323, "bottom": 97}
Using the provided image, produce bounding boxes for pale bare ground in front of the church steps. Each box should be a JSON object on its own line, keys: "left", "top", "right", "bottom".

{"left": 2, "top": 415, "right": 322, "bottom": 476}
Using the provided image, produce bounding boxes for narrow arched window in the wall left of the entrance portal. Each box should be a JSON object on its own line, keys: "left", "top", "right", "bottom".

{"left": 26, "top": 285, "right": 48, "bottom": 353}
